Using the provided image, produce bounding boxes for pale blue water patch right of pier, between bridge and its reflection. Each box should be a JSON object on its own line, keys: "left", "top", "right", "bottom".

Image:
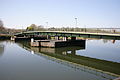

{"left": 76, "top": 39, "right": 120, "bottom": 63}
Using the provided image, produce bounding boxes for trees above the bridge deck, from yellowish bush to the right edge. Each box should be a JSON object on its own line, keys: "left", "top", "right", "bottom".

{"left": 25, "top": 24, "right": 120, "bottom": 33}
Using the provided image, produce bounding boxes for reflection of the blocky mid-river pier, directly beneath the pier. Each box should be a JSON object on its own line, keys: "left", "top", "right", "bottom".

{"left": 37, "top": 46, "right": 85, "bottom": 55}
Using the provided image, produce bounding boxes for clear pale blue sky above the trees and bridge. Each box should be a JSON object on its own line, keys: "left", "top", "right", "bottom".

{"left": 0, "top": 0, "right": 120, "bottom": 29}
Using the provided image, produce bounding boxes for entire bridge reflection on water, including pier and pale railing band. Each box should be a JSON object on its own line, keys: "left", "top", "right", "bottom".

{"left": 18, "top": 41, "right": 120, "bottom": 80}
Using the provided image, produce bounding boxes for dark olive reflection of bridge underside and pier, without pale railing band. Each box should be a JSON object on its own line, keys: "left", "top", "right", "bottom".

{"left": 19, "top": 40, "right": 120, "bottom": 75}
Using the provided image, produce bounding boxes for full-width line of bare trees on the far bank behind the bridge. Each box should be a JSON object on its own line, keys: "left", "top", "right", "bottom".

{"left": 0, "top": 20, "right": 120, "bottom": 34}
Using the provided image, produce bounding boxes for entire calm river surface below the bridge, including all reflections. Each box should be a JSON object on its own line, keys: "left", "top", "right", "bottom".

{"left": 0, "top": 39, "right": 120, "bottom": 80}
